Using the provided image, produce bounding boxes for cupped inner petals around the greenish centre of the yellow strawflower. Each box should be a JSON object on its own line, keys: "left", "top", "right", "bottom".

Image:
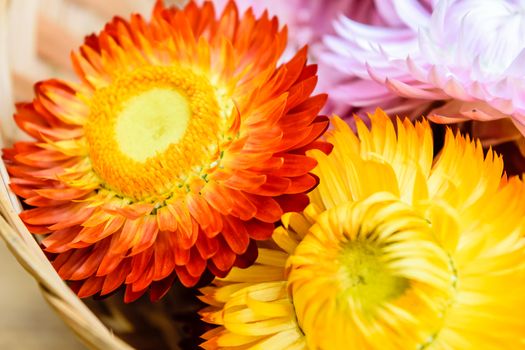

{"left": 287, "top": 196, "right": 455, "bottom": 349}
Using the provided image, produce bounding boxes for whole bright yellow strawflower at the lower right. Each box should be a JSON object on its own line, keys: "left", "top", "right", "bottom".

{"left": 202, "top": 110, "right": 525, "bottom": 350}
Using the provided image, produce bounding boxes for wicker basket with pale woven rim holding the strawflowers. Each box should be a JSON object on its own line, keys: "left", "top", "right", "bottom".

{"left": 0, "top": 0, "right": 198, "bottom": 349}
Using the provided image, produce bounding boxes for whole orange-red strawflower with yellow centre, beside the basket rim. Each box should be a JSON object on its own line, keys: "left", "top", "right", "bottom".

{"left": 4, "top": 1, "right": 330, "bottom": 302}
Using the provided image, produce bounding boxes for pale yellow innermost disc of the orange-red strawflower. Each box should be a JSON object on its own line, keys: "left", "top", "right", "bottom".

{"left": 115, "top": 88, "right": 191, "bottom": 162}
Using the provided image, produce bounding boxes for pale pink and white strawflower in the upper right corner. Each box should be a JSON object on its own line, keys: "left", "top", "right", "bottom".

{"left": 322, "top": 0, "right": 525, "bottom": 133}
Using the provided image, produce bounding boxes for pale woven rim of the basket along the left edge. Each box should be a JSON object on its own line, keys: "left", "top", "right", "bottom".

{"left": 0, "top": 0, "right": 136, "bottom": 349}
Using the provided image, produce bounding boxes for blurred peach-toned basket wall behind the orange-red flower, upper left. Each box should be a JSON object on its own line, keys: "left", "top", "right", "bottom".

{"left": 0, "top": 0, "right": 162, "bottom": 142}
